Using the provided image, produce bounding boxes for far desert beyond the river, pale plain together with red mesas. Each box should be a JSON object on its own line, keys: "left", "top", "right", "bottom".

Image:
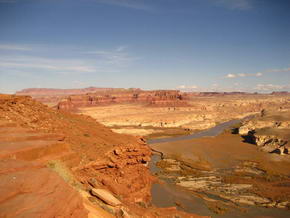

{"left": 16, "top": 87, "right": 289, "bottom": 138}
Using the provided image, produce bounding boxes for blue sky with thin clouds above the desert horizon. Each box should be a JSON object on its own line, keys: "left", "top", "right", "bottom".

{"left": 0, "top": 0, "right": 290, "bottom": 93}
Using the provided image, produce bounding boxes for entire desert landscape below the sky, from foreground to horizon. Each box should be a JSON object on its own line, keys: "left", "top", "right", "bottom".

{"left": 0, "top": 89, "right": 290, "bottom": 217}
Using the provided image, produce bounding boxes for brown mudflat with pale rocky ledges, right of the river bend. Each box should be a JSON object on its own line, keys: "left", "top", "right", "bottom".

{"left": 150, "top": 111, "right": 290, "bottom": 217}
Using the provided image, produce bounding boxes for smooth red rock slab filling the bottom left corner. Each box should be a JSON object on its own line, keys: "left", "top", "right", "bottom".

{"left": 0, "top": 160, "right": 88, "bottom": 218}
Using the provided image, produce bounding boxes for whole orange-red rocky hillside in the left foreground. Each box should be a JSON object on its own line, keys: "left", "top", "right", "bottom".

{"left": 0, "top": 95, "right": 206, "bottom": 218}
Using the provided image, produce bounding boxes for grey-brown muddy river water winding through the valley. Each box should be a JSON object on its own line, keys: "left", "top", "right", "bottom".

{"left": 148, "top": 120, "right": 290, "bottom": 218}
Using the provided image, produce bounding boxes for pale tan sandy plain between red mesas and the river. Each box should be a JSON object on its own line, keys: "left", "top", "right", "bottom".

{"left": 78, "top": 95, "right": 289, "bottom": 138}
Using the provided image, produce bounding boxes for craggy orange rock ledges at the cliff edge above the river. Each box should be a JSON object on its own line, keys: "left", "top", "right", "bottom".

{"left": 73, "top": 144, "right": 154, "bottom": 204}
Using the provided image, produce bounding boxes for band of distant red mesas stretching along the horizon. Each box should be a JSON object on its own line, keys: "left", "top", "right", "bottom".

{"left": 16, "top": 87, "right": 289, "bottom": 110}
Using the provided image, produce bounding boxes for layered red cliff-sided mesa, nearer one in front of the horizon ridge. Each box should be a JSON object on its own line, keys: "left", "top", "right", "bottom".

{"left": 57, "top": 90, "right": 188, "bottom": 110}
